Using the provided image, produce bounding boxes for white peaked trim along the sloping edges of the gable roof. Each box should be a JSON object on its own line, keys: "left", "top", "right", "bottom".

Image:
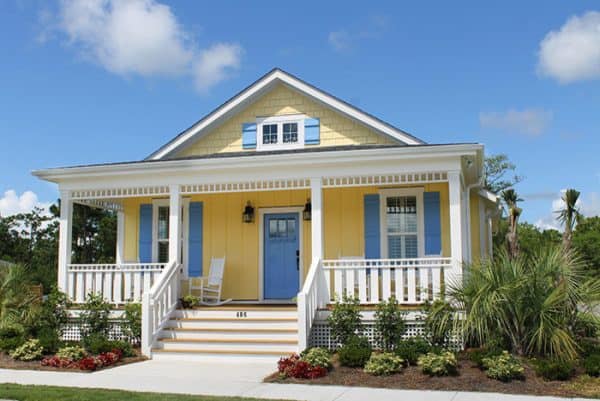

{"left": 147, "top": 70, "right": 424, "bottom": 160}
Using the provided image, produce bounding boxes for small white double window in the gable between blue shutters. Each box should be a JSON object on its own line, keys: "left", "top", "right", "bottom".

{"left": 256, "top": 115, "right": 305, "bottom": 150}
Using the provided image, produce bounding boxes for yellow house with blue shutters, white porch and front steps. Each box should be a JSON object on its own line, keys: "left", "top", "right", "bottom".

{"left": 34, "top": 69, "right": 497, "bottom": 356}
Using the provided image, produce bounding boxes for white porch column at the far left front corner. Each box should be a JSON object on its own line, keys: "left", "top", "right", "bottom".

{"left": 58, "top": 191, "right": 73, "bottom": 293}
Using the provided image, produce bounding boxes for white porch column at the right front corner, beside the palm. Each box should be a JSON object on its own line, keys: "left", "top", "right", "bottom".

{"left": 444, "top": 171, "right": 465, "bottom": 283}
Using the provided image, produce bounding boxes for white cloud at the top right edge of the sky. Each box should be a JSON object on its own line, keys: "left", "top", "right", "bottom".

{"left": 538, "top": 11, "right": 600, "bottom": 83}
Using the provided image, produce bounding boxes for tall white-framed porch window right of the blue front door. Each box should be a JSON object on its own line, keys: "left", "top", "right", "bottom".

{"left": 380, "top": 188, "right": 424, "bottom": 259}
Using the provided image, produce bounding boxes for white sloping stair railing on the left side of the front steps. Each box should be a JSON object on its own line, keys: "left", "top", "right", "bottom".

{"left": 141, "top": 262, "right": 181, "bottom": 357}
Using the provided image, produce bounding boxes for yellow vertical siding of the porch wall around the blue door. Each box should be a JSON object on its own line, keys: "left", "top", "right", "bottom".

{"left": 124, "top": 183, "right": 450, "bottom": 300}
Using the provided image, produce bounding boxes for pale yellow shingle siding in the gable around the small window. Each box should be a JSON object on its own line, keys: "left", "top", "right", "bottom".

{"left": 177, "top": 84, "right": 397, "bottom": 157}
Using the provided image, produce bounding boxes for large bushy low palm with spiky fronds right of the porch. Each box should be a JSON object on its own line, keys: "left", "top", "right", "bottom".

{"left": 448, "top": 247, "right": 600, "bottom": 359}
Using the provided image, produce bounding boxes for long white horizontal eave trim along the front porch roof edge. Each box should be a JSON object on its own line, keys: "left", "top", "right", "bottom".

{"left": 32, "top": 144, "right": 483, "bottom": 182}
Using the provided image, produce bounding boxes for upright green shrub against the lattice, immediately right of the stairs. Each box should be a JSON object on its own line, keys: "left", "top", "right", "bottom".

{"left": 327, "top": 295, "right": 362, "bottom": 344}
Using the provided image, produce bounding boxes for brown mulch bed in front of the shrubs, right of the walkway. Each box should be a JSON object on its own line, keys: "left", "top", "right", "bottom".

{"left": 265, "top": 355, "right": 600, "bottom": 397}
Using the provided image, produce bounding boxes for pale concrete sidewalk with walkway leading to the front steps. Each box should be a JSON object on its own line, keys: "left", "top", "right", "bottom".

{"left": 0, "top": 360, "right": 583, "bottom": 401}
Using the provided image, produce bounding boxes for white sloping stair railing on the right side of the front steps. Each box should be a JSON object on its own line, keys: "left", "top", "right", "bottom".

{"left": 297, "top": 258, "right": 329, "bottom": 351}
